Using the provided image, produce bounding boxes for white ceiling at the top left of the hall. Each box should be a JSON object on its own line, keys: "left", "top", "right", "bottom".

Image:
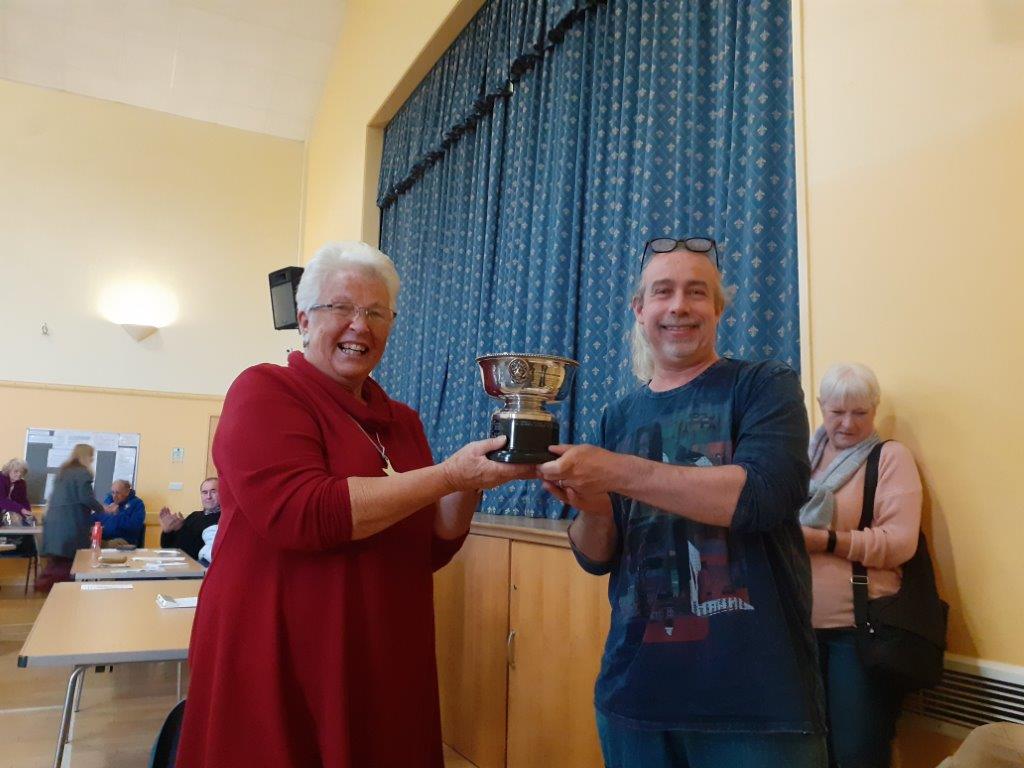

{"left": 0, "top": 0, "right": 344, "bottom": 140}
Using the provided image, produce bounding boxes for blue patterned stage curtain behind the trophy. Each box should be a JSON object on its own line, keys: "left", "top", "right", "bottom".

{"left": 379, "top": 0, "right": 800, "bottom": 517}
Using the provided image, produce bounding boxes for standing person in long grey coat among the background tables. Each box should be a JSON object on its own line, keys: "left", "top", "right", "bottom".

{"left": 36, "top": 442, "right": 103, "bottom": 592}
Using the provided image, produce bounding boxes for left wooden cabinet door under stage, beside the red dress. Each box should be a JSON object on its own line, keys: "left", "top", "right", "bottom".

{"left": 434, "top": 535, "right": 509, "bottom": 768}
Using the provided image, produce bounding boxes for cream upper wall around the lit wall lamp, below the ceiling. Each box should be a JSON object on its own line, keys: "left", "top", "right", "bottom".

{"left": 0, "top": 80, "right": 303, "bottom": 397}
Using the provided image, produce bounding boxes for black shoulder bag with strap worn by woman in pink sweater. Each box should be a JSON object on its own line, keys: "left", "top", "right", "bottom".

{"left": 850, "top": 442, "right": 949, "bottom": 693}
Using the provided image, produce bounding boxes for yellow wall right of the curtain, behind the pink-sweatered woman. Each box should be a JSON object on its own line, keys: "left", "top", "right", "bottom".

{"left": 803, "top": 0, "right": 1024, "bottom": 665}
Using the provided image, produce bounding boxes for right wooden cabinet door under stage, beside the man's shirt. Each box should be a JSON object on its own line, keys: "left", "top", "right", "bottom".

{"left": 507, "top": 542, "right": 610, "bottom": 768}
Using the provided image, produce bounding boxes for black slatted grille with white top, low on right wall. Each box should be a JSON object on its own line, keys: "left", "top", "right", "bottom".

{"left": 903, "top": 653, "right": 1024, "bottom": 738}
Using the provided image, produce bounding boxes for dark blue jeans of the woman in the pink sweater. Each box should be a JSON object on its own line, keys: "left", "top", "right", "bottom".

{"left": 817, "top": 629, "right": 903, "bottom": 768}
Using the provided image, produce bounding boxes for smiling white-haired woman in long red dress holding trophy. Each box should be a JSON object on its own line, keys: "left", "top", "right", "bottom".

{"left": 176, "top": 243, "right": 534, "bottom": 768}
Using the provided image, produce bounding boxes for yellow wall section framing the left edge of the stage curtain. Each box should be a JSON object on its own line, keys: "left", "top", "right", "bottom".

{"left": 303, "top": 0, "right": 483, "bottom": 252}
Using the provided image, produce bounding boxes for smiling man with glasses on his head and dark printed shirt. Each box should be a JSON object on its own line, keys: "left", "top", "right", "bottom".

{"left": 539, "top": 238, "right": 826, "bottom": 768}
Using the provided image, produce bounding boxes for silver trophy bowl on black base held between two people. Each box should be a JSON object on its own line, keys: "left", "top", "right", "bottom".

{"left": 476, "top": 353, "right": 580, "bottom": 464}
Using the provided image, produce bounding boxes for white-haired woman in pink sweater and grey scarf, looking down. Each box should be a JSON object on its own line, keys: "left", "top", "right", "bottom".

{"left": 800, "top": 364, "right": 922, "bottom": 768}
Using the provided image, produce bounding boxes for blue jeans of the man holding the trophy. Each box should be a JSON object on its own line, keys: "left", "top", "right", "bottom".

{"left": 597, "top": 713, "right": 828, "bottom": 768}
